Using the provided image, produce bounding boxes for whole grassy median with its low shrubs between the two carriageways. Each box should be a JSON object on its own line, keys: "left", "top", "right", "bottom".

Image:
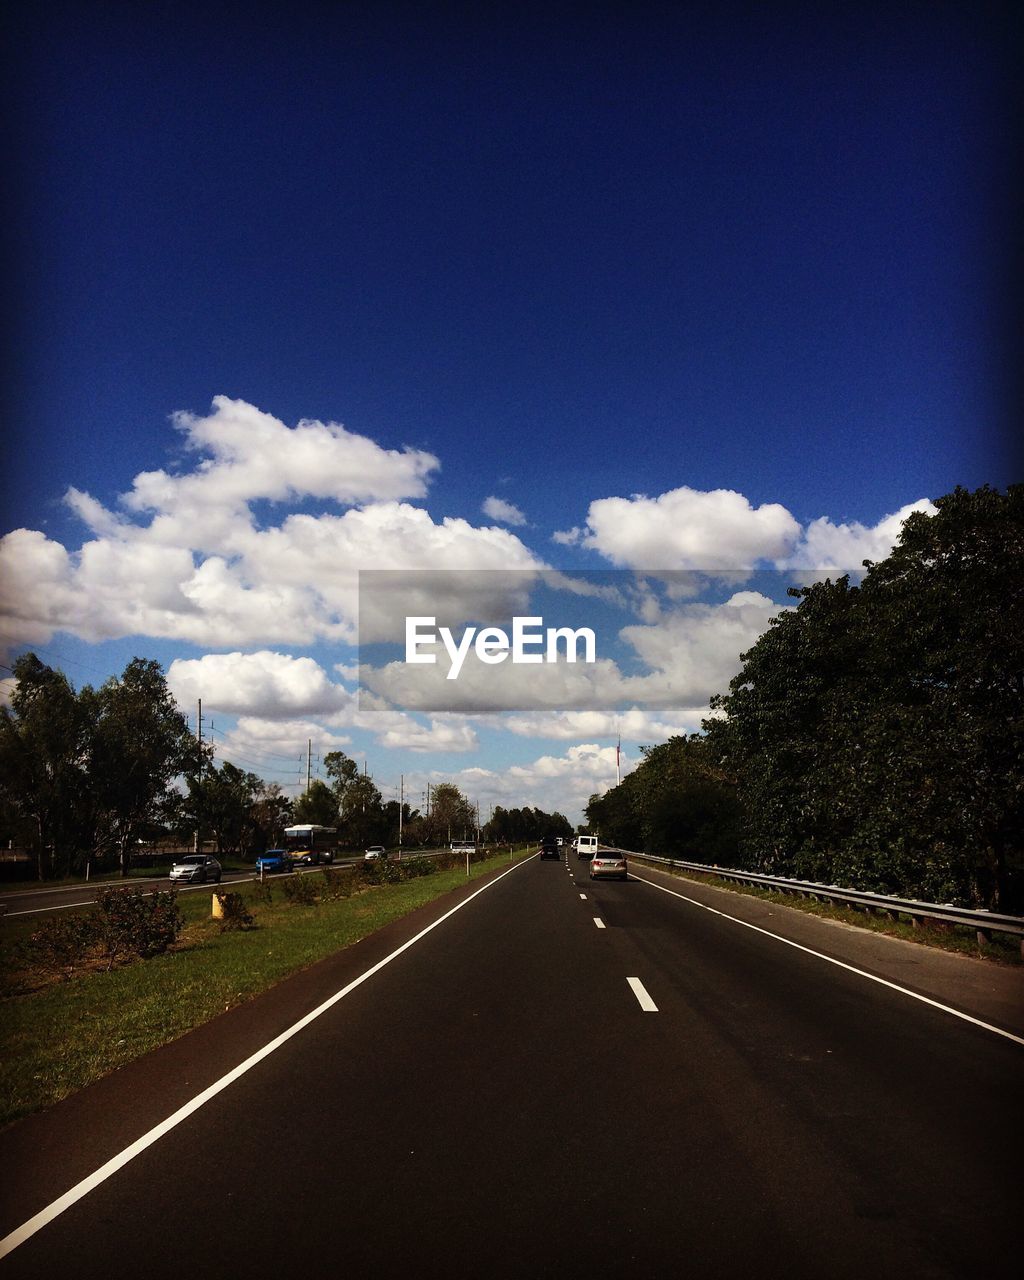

{"left": 0, "top": 852, "right": 532, "bottom": 1124}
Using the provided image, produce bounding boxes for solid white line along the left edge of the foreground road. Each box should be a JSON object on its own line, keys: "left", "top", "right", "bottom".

{"left": 0, "top": 858, "right": 530, "bottom": 1258}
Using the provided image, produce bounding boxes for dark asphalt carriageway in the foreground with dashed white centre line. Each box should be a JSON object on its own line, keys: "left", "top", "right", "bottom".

{"left": 0, "top": 858, "right": 1024, "bottom": 1280}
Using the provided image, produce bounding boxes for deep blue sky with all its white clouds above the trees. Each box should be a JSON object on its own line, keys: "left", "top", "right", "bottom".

{"left": 0, "top": 0, "right": 1024, "bottom": 820}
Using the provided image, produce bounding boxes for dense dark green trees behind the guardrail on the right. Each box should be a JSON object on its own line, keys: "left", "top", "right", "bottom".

{"left": 586, "top": 485, "right": 1024, "bottom": 911}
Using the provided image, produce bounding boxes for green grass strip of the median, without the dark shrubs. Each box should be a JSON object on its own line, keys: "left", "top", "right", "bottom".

{"left": 0, "top": 855, "right": 527, "bottom": 1125}
